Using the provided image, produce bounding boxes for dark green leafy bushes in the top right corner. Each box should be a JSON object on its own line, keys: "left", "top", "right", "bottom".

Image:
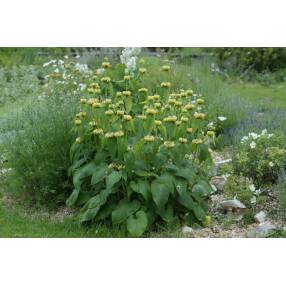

{"left": 215, "top": 48, "right": 286, "bottom": 72}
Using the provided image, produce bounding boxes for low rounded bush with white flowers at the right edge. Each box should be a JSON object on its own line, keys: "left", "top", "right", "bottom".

{"left": 233, "top": 130, "right": 286, "bottom": 187}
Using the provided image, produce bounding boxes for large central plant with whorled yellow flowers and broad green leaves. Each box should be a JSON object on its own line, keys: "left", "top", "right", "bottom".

{"left": 67, "top": 56, "right": 215, "bottom": 236}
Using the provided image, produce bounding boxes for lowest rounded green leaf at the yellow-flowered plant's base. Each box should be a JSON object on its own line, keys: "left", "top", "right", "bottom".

{"left": 126, "top": 210, "right": 148, "bottom": 237}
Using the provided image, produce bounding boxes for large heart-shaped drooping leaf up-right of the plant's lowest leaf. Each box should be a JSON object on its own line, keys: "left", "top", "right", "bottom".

{"left": 151, "top": 173, "right": 174, "bottom": 209}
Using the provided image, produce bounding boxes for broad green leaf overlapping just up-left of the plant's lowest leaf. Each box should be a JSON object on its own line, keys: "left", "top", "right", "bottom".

{"left": 111, "top": 199, "right": 141, "bottom": 224}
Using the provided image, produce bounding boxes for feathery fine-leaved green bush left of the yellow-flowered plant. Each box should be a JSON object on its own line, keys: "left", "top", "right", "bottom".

{"left": 3, "top": 95, "right": 75, "bottom": 206}
